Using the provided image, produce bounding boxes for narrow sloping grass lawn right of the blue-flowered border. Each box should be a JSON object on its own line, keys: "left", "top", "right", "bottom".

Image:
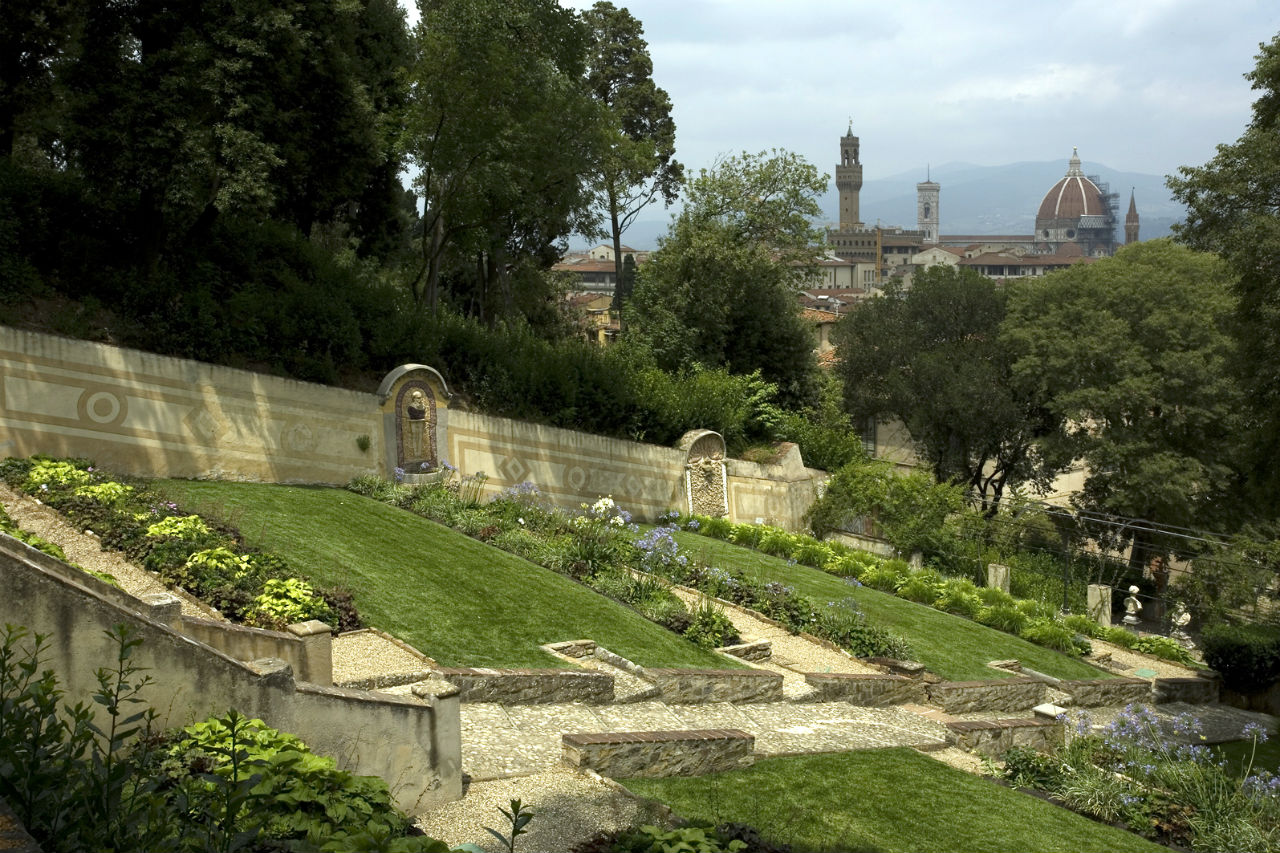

{"left": 676, "top": 532, "right": 1110, "bottom": 681}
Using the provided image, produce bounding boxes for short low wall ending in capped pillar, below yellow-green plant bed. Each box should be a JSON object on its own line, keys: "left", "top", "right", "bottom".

{"left": 174, "top": 616, "right": 333, "bottom": 685}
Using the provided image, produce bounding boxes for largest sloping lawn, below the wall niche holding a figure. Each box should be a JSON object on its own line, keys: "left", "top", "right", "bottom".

{"left": 156, "top": 480, "right": 732, "bottom": 669}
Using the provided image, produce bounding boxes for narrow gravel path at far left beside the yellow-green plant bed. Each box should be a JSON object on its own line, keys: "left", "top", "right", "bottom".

{"left": 0, "top": 483, "right": 221, "bottom": 619}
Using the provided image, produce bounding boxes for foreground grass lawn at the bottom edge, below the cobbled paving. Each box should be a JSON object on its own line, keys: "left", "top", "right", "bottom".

{"left": 620, "top": 748, "right": 1167, "bottom": 853}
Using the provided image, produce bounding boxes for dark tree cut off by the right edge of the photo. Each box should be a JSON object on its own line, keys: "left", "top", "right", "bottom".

{"left": 1169, "top": 36, "right": 1280, "bottom": 515}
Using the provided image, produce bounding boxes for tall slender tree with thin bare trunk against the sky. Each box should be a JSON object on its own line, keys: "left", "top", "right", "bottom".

{"left": 582, "top": 0, "right": 684, "bottom": 310}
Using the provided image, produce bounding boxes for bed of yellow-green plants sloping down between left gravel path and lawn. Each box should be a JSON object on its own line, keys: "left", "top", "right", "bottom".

{"left": 0, "top": 456, "right": 361, "bottom": 631}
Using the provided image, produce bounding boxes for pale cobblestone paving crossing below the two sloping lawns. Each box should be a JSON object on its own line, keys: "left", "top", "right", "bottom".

{"left": 462, "top": 702, "right": 947, "bottom": 780}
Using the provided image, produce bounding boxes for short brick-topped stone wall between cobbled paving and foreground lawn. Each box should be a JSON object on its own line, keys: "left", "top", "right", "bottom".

{"left": 561, "top": 729, "right": 755, "bottom": 777}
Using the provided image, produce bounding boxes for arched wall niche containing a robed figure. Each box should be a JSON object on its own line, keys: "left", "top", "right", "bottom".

{"left": 378, "top": 364, "right": 453, "bottom": 473}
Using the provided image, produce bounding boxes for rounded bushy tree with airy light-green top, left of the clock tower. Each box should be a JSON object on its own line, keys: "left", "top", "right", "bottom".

{"left": 625, "top": 151, "right": 827, "bottom": 406}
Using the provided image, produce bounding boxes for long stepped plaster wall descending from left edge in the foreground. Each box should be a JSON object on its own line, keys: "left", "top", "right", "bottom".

{"left": 0, "top": 534, "right": 462, "bottom": 813}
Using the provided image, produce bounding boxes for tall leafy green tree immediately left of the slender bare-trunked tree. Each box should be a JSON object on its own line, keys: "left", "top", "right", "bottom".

{"left": 407, "top": 0, "right": 608, "bottom": 321}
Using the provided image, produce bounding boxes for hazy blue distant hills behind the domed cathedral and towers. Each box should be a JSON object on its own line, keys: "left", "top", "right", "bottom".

{"left": 571, "top": 158, "right": 1185, "bottom": 248}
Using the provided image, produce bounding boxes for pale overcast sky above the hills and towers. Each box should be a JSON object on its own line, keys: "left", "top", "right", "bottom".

{"left": 411, "top": 0, "right": 1280, "bottom": 179}
